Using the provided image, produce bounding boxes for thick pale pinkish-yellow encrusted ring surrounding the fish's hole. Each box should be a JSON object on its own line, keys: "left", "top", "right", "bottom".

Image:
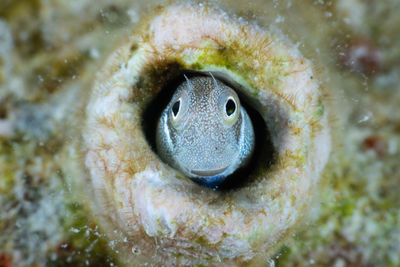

{"left": 84, "top": 3, "right": 330, "bottom": 265}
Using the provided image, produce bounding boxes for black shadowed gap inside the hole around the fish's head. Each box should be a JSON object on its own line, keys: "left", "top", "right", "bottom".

{"left": 142, "top": 72, "right": 275, "bottom": 191}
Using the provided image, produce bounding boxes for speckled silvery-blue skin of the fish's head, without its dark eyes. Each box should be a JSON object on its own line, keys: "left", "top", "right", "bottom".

{"left": 157, "top": 77, "right": 254, "bottom": 186}
